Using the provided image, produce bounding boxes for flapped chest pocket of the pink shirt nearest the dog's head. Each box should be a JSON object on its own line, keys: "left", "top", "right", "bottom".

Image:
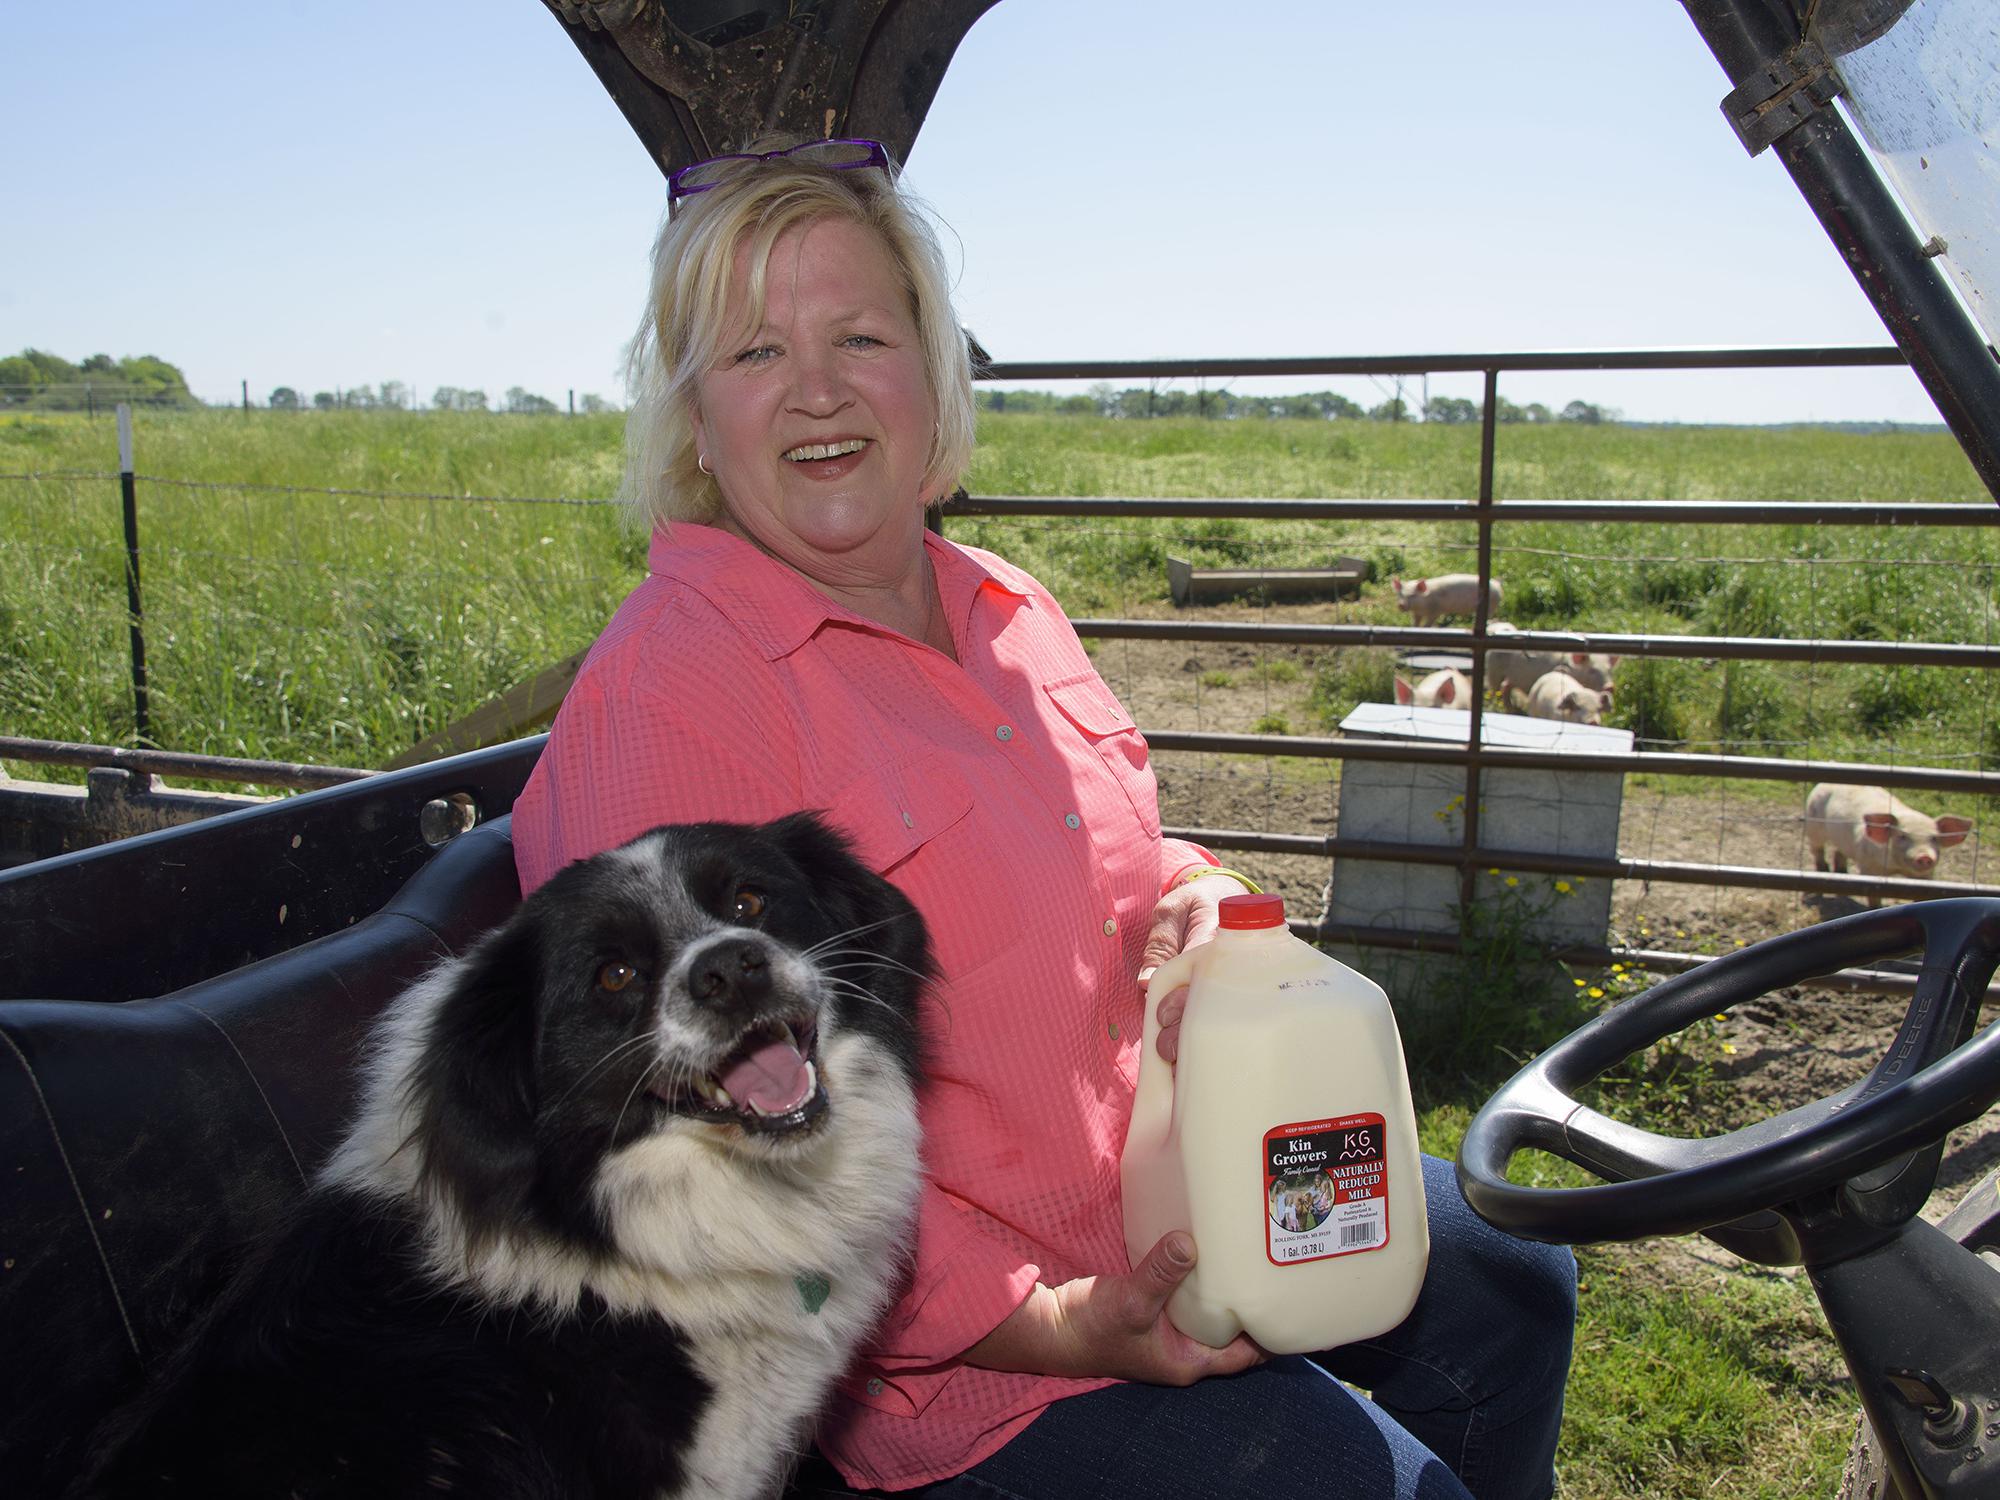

{"left": 828, "top": 758, "right": 1024, "bottom": 984}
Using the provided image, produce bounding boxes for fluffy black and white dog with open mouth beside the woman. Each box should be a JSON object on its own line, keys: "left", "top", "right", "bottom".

{"left": 74, "top": 814, "right": 932, "bottom": 1500}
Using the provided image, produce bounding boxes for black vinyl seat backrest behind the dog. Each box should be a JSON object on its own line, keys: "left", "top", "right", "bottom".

{"left": 0, "top": 818, "right": 520, "bottom": 1496}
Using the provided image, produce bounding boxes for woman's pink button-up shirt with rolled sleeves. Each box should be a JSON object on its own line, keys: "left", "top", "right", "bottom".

{"left": 514, "top": 524, "right": 1208, "bottom": 1488}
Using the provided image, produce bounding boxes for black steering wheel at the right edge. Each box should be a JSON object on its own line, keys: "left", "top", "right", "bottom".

{"left": 1458, "top": 896, "right": 2000, "bottom": 1244}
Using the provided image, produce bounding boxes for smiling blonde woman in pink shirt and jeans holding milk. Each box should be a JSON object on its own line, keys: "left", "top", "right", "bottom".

{"left": 514, "top": 142, "right": 1574, "bottom": 1496}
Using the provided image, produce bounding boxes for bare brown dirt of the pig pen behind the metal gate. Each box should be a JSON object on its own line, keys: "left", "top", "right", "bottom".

{"left": 1096, "top": 606, "right": 2000, "bottom": 1270}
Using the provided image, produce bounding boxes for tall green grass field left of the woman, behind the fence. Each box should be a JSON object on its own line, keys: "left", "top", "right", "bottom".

{"left": 0, "top": 412, "right": 644, "bottom": 766}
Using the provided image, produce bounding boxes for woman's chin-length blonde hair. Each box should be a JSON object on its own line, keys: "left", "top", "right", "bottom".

{"left": 618, "top": 142, "right": 974, "bottom": 528}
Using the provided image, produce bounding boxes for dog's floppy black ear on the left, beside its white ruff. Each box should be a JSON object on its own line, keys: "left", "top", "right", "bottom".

{"left": 412, "top": 904, "right": 542, "bottom": 1236}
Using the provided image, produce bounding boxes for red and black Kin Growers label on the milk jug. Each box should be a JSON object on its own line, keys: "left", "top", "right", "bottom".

{"left": 1264, "top": 1114, "right": 1388, "bottom": 1266}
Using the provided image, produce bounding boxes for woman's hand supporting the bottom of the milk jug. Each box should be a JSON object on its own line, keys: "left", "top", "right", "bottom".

{"left": 964, "top": 1230, "right": 1268, "bottom": 1386}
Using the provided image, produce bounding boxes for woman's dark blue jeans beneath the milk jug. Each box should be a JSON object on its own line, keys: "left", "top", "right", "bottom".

{"left": 918, "top": 1156, "right": 1576, "bottom": 1500}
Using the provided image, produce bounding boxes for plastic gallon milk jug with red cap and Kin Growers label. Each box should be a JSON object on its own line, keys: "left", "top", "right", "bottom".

{"left": 1122, "top": 896, "right": 1430, "bottom": 1354}
